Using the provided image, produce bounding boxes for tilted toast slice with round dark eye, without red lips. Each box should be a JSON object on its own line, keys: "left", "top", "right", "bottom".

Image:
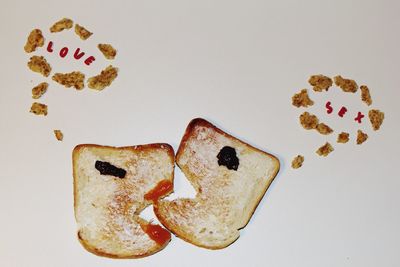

{"left": 154, "top": 119, "right": 280, "bottom": 249}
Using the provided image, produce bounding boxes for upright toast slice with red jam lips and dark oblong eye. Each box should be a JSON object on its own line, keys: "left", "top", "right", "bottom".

{"left": 72, "top": 144, "right": 174, "bottom": 258}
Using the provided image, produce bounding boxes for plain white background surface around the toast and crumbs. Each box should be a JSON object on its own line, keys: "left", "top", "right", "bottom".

{"left": 0, "top": 0, "right": 400, "bottom": 267}
